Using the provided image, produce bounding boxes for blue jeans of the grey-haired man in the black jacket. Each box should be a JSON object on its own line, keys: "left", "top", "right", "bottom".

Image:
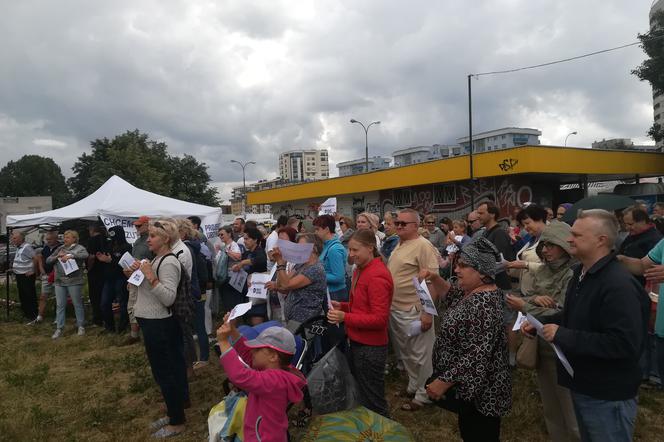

{"left": 571, "top": 391, "right": 637, "bottom": 442}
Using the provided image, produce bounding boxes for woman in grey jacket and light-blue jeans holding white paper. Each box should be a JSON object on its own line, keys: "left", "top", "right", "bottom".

{"left": 46, "top": 230, "right": 88, "bottom": 339}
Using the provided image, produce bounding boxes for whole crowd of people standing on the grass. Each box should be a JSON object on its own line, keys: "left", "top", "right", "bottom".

{"left": 12, "top": 201, "right": 664, "bottom": 441}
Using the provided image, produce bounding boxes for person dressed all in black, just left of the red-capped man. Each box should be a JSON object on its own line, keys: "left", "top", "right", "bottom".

{"left": 96, "top": 226, "right": 131, "bottom": 333}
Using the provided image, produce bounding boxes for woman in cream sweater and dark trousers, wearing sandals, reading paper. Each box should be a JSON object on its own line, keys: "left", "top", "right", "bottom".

{"left": 130, "top": 221, "right": 189, "bottom": 439}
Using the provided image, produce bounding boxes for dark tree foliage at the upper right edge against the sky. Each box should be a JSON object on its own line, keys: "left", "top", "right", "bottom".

{"left": 632, "top": 11, "right": 664, "bottom": 141}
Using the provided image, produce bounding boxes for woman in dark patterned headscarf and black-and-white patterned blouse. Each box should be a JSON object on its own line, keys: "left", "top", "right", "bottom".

{"left": 420, "top": 238, "right": 512, "bottom": 441}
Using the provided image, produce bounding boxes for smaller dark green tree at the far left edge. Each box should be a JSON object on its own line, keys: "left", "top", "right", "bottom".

{"left": 0, "top": 155, "right": 71, "bottom": 208}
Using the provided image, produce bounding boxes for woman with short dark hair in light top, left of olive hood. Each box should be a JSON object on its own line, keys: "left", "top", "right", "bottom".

{"left": 507, "top": 204, "right": 547, "bottom": 296}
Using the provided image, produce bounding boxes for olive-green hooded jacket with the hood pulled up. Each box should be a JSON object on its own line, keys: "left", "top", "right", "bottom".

{"left": 523, "top": 221, "right": 576, "bottom": 317}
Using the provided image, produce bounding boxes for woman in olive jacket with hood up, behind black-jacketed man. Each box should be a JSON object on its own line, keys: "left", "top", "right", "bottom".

{"left": 507, "top": 221, "right": 579, "bottom": 442}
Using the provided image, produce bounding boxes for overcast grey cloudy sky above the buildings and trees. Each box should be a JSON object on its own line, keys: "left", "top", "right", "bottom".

{"left": 0, "top": 0, "right": 653, "bottom": 197}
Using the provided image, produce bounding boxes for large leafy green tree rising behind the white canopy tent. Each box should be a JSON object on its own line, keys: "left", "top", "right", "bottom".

{"left": 68, "top": 129, "right": 219, "bottom": 205}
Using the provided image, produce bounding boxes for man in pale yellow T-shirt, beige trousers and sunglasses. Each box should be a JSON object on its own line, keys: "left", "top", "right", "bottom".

{"left": 387, "top": 209, "right": 438, "bottom": 411}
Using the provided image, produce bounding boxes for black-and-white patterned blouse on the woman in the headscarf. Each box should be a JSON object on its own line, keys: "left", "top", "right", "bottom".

{"left": 433, "top": 286, "right": 512, "bottom": 416}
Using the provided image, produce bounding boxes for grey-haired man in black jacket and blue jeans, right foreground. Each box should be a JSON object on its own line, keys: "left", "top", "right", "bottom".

{"left": 523, "top": 209, "right": 650, "bottom": 441}
